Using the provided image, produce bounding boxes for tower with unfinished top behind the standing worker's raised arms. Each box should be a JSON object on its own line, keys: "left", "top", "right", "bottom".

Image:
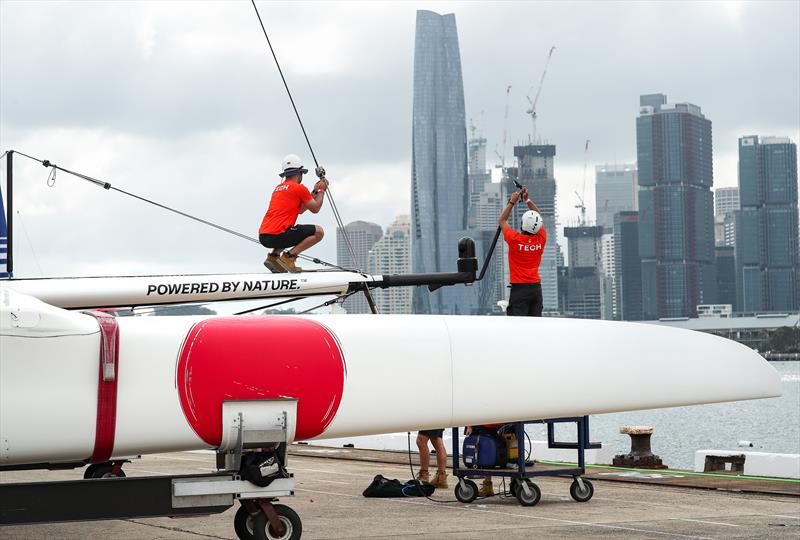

{"left": 509, "top": 144, "right": 560, "bottom": 311}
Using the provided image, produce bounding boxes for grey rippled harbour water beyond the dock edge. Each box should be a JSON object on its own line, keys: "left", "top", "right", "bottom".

{"left": 320, "top": 362, "right": 800, "bottom": 469}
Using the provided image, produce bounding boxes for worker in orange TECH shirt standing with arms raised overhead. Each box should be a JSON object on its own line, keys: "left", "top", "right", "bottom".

{"left": 499, "top": 188, "right": 547, "bottom": 317}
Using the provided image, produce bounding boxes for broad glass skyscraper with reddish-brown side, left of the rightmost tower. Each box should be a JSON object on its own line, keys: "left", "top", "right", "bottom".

{"left": 636, "top": 94, "right": 716, "bottom": 319}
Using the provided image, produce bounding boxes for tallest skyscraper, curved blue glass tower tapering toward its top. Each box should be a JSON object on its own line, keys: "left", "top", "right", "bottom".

{"left": 411, "top": 11, "right": 468, "bottom": 314}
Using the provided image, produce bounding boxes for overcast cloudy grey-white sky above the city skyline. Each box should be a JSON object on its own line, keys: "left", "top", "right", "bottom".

{"left": 0, "top": 0, "right": 800, "bottom": 277}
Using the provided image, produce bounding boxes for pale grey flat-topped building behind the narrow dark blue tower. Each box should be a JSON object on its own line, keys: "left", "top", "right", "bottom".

{"left": 594, "top": 163, "right": 639, "bottom": 229}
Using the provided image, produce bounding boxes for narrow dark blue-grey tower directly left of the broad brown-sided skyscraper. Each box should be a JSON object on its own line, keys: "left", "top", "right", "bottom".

{"left": 614, "top": 212, "right": 642, "bottom": 321}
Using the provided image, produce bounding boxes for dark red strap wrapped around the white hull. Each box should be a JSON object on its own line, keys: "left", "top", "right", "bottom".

{"left": 84, "top": 311, "right": 119, "bottom": 463}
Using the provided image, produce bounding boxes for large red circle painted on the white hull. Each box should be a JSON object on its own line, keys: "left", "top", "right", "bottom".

{"left": 176, "top": 315, "right": 346, "bottom": 446}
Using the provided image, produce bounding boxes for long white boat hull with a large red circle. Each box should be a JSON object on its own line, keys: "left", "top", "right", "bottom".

{"left": 0, "top": 287, "right": 781, "bottom": 465}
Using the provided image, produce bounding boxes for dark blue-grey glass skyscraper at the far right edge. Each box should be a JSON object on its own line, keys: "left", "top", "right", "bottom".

{"left": 735, "top": 136, "right": 800, "bottom": 311}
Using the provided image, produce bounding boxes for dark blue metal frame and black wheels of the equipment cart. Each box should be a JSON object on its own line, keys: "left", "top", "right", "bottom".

{"left": 453, "top": 416, "right": 601, "bottom": 506}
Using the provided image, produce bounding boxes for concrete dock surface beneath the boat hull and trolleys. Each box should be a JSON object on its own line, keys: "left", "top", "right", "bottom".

{"left": 0, "top": 446, "right": 800, "bottom": 540}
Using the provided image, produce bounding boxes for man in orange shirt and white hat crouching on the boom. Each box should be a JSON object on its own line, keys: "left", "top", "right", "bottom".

{"left": 258, "top": 154, "right": 328, "bottom": 273}
